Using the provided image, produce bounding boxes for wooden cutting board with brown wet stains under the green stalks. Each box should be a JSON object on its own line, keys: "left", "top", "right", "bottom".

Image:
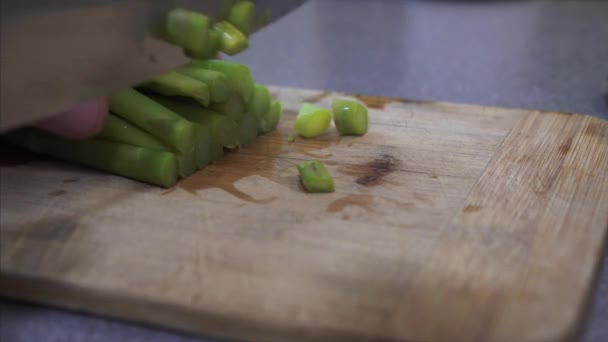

{"left": 0, "top": 88, "right": 608, "bottom": 342}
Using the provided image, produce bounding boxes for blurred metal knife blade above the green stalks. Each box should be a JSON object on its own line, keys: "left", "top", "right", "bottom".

{"left": 0, "top": 0, "right": 305, "bottom": 133}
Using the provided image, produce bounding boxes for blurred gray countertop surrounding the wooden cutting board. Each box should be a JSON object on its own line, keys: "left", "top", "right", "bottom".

{"left": 0, "top": 0, "right": 608, "bottom": 342}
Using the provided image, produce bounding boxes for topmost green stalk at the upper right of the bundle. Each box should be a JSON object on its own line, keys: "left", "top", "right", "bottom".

{"left": 190, "top": 59, "right": 255, "bottom": 104}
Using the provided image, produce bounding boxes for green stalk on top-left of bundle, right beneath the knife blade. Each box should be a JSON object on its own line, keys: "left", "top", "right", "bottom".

{"left": 141, "top": 71, "right": 211, "bottom": 106}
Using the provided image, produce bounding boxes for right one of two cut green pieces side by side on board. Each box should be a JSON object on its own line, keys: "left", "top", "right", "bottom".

{"left": 332, "top": 99, "right": 368, "bottom": 136}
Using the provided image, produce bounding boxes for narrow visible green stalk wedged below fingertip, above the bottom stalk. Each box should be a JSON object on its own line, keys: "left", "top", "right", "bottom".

{"left": 95, "top": 113, "right": 172, "bottom": 152}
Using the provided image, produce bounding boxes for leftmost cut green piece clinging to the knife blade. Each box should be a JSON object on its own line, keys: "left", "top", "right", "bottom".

{"left": 165, "top": 8, "right": 209, "bottom": 51}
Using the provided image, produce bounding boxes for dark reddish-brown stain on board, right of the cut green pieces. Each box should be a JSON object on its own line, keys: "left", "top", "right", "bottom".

{"left": 338, "top": 154, "right": 401, "bottom": 186}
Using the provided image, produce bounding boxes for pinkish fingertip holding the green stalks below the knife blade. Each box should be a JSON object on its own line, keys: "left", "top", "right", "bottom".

{"left": 34, "top": 98, "right": 108, "bottom": 140}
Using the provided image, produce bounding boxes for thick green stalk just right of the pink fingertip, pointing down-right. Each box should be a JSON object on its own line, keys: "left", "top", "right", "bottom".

{"left": 109, "top": 88, "right": 195, "bottom": 153}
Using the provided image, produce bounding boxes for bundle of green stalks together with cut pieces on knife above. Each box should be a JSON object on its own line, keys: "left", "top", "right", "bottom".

{"left": 4, "top": 1, "right": 283, "bottom": 187}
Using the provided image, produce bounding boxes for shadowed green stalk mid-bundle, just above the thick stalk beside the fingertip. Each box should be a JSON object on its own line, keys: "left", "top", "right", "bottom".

{"left": 152, "top": 96, "right": 239, "bottom": 148}
